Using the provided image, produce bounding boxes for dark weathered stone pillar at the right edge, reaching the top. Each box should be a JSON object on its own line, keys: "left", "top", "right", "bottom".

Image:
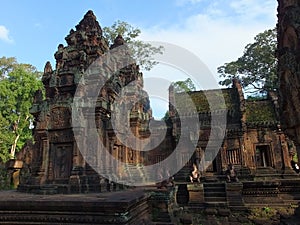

{"left": 277, "top": 0, "right": 300, "bottom": 166}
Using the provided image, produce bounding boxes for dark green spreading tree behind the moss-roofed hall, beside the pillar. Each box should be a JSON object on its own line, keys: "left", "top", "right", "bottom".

{"left": 218, "top": 28, "right": 278, "bottom": 93}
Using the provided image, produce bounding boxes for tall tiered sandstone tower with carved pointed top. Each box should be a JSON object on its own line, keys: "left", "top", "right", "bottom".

{"left": 19, "top": 11, "right": 151, "bottom": 193}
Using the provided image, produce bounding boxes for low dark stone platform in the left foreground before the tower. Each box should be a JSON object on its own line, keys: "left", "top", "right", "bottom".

{"left": 0, "top": 189, "right": 151, "bottom": 225}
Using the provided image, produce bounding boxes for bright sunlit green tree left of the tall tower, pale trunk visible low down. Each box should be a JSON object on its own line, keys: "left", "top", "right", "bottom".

{"left": 0, "top": 57, "right": 42, "bottom": 161}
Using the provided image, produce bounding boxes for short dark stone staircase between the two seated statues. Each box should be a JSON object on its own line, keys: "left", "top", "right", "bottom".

{"left": 203, "top": 182, "right": 227, "bottom": 204}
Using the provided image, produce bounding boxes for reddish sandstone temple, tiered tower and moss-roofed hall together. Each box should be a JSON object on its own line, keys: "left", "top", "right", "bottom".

{"left": 18, "top": 11, "right": 296, "bottom": 196}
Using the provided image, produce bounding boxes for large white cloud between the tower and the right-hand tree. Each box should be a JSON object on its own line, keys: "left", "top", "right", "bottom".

{"left": 141, "top": 0, "right": 277, "bottom": 83}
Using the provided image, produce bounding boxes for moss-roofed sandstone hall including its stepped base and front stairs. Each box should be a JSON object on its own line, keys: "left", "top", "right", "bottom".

{"left": 170, "top": 80, "right": 300, "bottom": 214}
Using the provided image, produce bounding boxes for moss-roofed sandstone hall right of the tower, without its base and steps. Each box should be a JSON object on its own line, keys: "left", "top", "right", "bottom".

{"left": 170, "top": 80, "right": 292, "bottom": 180}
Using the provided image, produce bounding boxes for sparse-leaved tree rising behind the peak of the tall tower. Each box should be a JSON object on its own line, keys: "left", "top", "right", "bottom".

{"left": 103, "top": 20, "right": 163, "bottom": 70}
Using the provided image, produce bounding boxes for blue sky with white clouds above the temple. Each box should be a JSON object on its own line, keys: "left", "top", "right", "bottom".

{"left": 0, "top": 0, "right": 277, "bottom": 118}
